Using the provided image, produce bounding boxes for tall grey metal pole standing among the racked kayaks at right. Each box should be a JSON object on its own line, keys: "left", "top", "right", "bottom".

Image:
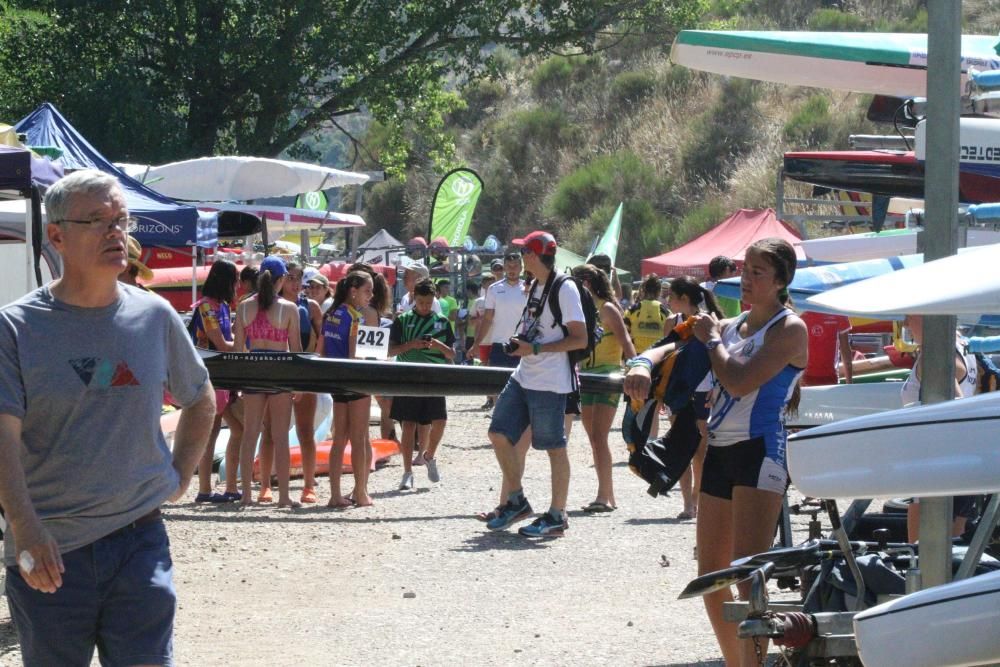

{"left": 920, "top": 0, "right": 962, "bottom": 588}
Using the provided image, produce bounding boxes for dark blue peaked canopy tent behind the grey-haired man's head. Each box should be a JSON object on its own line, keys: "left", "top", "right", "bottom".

{"left": 15, "top": 102, "right": 200, "bottom": 248}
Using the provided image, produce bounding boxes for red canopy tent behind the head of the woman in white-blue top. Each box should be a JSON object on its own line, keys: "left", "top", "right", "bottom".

{"left": 642, "top": 208, "right": 806, "bottom": 279}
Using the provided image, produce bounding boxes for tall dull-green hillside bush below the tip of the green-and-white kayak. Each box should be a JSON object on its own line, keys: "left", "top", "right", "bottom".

{"left": 681, "top": 79, "right": 758, "bottom": 187}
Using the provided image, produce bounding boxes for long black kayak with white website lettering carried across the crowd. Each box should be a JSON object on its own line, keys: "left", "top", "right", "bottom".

{"left": 201, "top": 352, "right": 622, "bottom": 396}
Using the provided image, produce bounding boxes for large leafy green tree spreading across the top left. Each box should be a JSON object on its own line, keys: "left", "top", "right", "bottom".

{"left": 0, "top": 0, "right": 703, "bottom": 168}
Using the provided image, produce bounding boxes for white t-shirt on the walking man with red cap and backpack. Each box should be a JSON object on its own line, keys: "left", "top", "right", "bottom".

{"left": 512, "top": 280, "right": 586, "bottom": 394}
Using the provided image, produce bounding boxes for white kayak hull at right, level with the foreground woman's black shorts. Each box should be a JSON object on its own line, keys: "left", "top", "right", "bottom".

{"left": 788, "top": 392, "right": 1000, "bottom": 498}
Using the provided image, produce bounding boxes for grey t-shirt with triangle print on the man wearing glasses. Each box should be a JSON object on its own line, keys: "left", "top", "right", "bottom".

{"left": 0, "top": 285, "right": 208, "bottom": 566}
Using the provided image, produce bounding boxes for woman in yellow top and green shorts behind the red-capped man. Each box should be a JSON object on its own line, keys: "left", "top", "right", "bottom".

{"left": 573, "top": 264, "right": 635, "bottom": 512}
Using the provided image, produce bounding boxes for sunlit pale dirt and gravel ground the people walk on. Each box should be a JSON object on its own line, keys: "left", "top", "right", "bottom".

{"left": 0, "top": 398, "right": 816, "bottom": 666}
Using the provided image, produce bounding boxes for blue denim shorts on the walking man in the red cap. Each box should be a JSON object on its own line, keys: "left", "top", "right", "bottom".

{"left": 490, "top": 380, "right": 566, "bottom": 449}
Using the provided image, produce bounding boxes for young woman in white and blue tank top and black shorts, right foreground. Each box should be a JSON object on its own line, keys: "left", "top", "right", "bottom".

{"left": 694, "top": 238, "right": 808, "bottom": 665}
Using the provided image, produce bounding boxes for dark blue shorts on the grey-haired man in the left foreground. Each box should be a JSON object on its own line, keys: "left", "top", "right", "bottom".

{"left": 7, "top": 521, "right": 177, "bottom": 665}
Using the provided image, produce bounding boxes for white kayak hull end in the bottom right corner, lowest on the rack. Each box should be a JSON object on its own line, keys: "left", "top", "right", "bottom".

{"left": 854, "top": 572, "right": 1000, "bottom": 667}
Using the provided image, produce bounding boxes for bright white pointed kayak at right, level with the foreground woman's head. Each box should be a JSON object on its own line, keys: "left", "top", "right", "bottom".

{"left": 804, "top": 244, "right": 1000, "bottom": 317}
